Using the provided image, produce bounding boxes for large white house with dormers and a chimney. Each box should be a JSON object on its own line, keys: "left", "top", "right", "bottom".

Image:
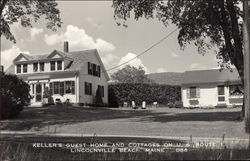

{"left": 6, "top": 42, "right": 109, "bottom": 103}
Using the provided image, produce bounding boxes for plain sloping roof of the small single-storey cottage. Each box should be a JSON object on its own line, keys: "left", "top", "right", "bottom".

{"left": 182, "top": 69, "right": 241, "bottom": 85}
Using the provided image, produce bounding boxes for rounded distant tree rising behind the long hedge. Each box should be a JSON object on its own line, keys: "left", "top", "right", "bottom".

{"left": 111, "top": 65, "right": 153, "bottom": 83}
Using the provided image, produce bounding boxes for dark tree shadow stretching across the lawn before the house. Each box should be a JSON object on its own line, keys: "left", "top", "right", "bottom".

{"left": 0, "top": 106, "right": 240, "bottom": 130}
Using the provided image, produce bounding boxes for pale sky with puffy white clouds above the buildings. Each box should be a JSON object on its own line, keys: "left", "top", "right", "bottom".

{"left": 1, "top": 1, "right": 222, "bottom": 74}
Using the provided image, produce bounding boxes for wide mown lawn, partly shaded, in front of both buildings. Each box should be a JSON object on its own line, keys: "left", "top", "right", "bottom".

{"left": 0, "top": 106, "right": 248, "bottom": 138}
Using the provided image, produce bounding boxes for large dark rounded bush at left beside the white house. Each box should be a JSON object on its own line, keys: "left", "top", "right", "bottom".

{"left": 0, "top": 73, "right": 31, "bottom": 119}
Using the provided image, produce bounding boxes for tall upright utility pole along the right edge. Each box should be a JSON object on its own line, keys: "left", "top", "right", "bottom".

{"left": 243, "top": 0, "right": 250, "bottom": 135}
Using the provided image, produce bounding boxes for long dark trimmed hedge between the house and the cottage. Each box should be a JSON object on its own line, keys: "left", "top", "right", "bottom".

{"left": 109, "top": 83, "right": 181, "bottom": 107}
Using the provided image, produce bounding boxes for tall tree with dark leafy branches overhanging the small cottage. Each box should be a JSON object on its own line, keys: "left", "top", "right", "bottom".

{"left": 112, "top": 0, "right": 244, "bottom": 82}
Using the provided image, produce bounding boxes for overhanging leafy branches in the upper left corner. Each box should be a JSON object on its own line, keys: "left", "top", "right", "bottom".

{"left": 0, "top": 0, "right": 62, "bottom": 43}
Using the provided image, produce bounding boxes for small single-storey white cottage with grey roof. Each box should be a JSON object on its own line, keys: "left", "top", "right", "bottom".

{"left": 181, "top": 69, "right": 243, "bottom": 107}
